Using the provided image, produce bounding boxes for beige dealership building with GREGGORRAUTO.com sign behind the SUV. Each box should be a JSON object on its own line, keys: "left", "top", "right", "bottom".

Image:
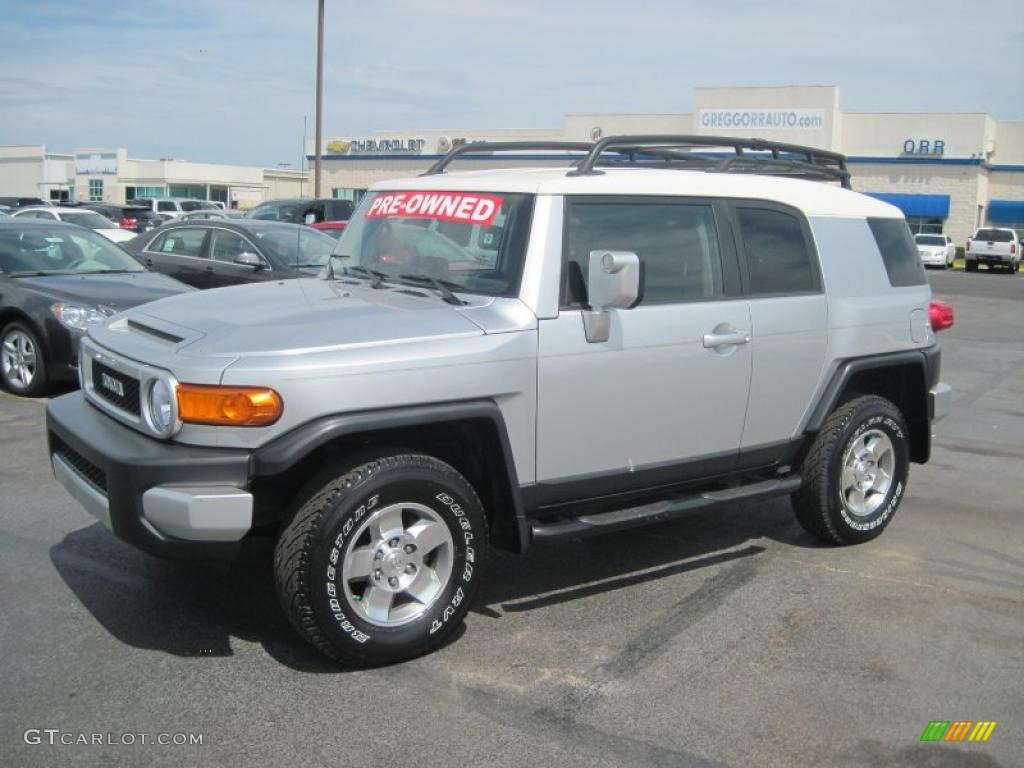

{"left": 307, "top": 86, "right": 1024, "bottom": 243}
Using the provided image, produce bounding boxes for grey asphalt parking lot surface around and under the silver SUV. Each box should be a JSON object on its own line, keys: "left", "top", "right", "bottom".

{"left": 0, "top": 272, "right": 1024, "bottom": 767}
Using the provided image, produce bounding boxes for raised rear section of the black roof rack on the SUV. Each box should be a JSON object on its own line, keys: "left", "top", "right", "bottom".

{"left": 569, "top": 135, "right": 850, "bottom": 189}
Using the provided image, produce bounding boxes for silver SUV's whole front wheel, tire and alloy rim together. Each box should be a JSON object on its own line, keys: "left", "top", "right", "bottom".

{"left": 274, "top": 454, "right": 487, "bottom": 667}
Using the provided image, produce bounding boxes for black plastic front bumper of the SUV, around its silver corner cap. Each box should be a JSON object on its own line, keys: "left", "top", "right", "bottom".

{"left": 46, "top": 392, "right": 251, "bottom": 560}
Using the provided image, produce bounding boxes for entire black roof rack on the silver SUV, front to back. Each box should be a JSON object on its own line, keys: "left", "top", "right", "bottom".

{"left": 424, "top": 135, "right": 851, "bottom": 189}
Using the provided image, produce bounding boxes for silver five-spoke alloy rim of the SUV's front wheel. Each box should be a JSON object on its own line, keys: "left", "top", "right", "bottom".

{"left": 341, "top": 502, "right": 455, "bottom": 627}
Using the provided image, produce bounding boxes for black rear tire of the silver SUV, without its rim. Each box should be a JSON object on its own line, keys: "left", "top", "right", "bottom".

{"left": 793, "top": 395, "right": 909, "bottom": 545}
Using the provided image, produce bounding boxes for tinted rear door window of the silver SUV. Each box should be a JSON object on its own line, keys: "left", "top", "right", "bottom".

{"left": 736, "top": 207, "right": 819, "bottom": 294}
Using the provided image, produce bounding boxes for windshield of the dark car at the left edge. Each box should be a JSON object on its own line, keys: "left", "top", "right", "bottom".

{"left": 0, "top": 226, "right": 145, "bottom": 274}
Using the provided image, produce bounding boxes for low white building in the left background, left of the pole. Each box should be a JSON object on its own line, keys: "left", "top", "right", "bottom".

{"left": 0, "top": 144, "right": 312, "bottom": 208}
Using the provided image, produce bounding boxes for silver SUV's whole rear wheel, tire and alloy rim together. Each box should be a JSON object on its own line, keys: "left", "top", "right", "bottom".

{"left": 793, "top": 395, "right": 910, "bottom": 544}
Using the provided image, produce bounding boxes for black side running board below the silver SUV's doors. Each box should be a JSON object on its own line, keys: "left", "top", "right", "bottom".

{"left": 532, "top": 475, "right": 801, "bottom": 540}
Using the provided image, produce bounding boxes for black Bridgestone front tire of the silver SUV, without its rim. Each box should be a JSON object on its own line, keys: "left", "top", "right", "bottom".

{"left": 273, "top": 454, "right": 487, "bottom": 667}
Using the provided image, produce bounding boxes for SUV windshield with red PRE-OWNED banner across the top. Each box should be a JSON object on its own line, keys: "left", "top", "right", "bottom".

{"left": 335, "top": 191, "right": 534, "bottom": 296}
